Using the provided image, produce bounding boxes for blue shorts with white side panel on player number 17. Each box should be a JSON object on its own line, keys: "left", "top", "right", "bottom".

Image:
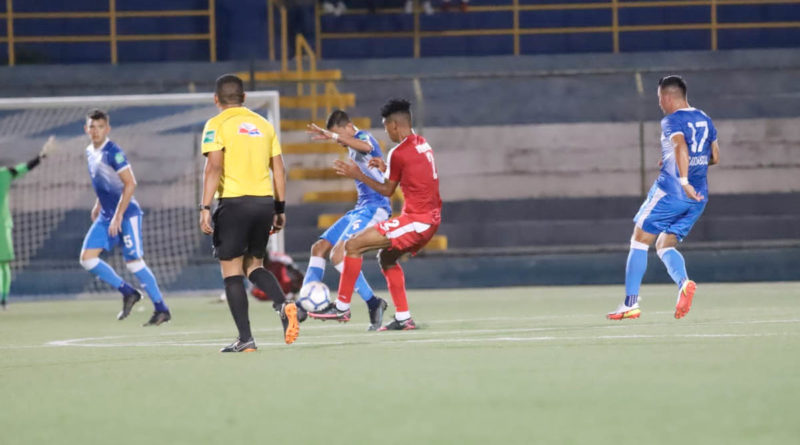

{"left": 633, "top": 185, "right": 706, "bottom": 241}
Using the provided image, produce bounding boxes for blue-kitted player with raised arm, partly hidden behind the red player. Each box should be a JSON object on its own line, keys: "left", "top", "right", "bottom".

{"left": 303, "top": 110, "right": 392, "bottom": 331}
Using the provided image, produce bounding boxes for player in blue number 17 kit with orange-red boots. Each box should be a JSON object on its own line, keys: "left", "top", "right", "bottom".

{"left": 607, "top": 76, "right": 719, "bottom": 320}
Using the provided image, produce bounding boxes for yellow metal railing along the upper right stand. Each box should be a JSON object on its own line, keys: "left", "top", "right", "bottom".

{"left": 314, "top": 0, "right": 800, "bottom": 58}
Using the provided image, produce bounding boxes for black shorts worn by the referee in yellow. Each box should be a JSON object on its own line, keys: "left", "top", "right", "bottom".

{"left": 212, "top": 196, "right": 275, "bottom": 260}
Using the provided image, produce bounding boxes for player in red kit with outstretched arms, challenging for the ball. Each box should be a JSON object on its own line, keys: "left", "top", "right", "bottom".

{"left": 308, "top": 99, "right": 442, "bottom": 331}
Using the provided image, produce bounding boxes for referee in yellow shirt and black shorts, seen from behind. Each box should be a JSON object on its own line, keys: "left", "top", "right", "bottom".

{"left": 200, "top": 74, "right": 300, "bottom": 352}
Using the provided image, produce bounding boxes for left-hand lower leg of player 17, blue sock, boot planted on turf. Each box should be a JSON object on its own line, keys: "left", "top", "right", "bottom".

{"left": 606, "top": 226, "right": 656, "bottom": 320}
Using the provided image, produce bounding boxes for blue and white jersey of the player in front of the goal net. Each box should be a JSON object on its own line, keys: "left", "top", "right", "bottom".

{"left": 86, "top": 139, "right": 142, "bottom": 220}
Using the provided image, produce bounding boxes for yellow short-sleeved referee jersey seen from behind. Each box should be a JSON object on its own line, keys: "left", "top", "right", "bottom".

{"left": 202, "top": 107, "right": 281, "bottom": 198}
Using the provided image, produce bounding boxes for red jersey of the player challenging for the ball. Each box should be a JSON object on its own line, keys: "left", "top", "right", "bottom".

{"left": 385, "top": 134, "right": 442, "bottom": 224}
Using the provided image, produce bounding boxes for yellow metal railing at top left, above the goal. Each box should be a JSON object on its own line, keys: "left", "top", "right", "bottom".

{"left": 0, "top": 0, "right": 217, "bottom": 66}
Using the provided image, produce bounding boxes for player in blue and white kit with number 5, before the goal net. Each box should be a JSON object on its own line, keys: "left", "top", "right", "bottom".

{"left": 80, "top": 110, "right": 172, "bottom": 326}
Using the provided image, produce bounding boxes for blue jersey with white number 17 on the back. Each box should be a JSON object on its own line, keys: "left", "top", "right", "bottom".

{"left": 656, "top": 108, "right": 717, "bottom": 200}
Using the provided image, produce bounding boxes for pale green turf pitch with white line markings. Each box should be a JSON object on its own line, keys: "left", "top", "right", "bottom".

{"left": 0, "top": 283, "right": 800, "bottom": 445}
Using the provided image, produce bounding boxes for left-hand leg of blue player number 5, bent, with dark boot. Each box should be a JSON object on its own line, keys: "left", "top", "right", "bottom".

{"left": 80, "top": 218, "right": 142, "bottom": 320}
